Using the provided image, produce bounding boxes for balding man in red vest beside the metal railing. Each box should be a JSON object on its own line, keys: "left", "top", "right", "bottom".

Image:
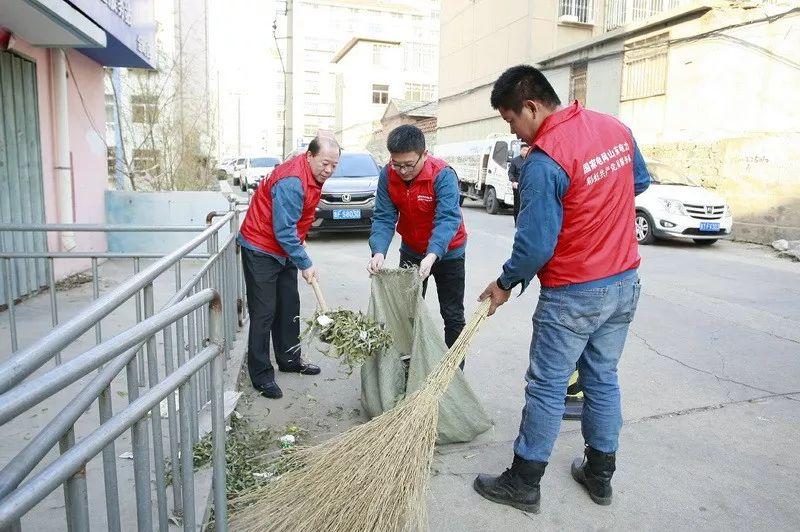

{"left": 238, "top": 137, "right": 341, "bottom": 399}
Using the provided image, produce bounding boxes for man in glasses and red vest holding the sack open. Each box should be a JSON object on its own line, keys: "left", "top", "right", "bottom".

{"left": 367, "top": 125, "right": 467, "bottom": 358}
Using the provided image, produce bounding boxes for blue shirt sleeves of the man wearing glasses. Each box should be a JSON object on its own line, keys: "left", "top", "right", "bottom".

{"left": 369, "top": 165, "right": 467, "bottom": 260}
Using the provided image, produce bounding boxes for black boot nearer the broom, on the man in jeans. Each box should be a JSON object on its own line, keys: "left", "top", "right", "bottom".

{"left": 472, "top": 455, "right": 547, "bottom": 514}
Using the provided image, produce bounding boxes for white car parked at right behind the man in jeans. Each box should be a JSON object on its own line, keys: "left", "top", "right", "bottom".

{"left": 636, "top": 161, "right": 733, "bottom": 246}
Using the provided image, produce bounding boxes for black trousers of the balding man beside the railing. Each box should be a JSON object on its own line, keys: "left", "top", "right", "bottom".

{"left": 242, "top": 248, "right": 302, "bottom": 387}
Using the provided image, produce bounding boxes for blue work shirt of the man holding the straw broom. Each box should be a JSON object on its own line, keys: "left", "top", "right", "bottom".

{"left": 497, "top": 141, "right": 650, "bottom": 290}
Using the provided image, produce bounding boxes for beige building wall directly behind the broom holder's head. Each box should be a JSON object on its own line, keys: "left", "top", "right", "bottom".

{"left": 438, "top": 0, "right": 687, "bottom": 142}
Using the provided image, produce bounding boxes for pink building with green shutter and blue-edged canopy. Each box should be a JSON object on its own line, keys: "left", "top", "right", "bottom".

{"left": 0, "top": 0, "right": 153, "bottom": 301}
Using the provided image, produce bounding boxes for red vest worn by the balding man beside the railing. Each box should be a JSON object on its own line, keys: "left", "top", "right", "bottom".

{"left": 240, "top": 153, "right": 322, "bottom": 257}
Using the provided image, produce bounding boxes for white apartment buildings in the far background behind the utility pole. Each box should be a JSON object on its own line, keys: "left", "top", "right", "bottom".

{"left": 282, "top": 0, "right": 439, "bottom": 154}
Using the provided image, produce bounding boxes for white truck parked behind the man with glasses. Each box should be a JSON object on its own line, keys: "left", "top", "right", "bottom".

{"left": 433, "top": 134, "right": 522, "bottom": 214}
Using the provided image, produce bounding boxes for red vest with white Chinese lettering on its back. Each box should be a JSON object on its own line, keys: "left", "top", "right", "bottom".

{"left": 533, "top": 101, "right": 641, "bottom": 287}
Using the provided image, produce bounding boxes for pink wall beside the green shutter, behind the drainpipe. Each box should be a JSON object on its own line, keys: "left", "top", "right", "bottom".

{"left": 15, "top": 39, "right": 108, "bottom": 277}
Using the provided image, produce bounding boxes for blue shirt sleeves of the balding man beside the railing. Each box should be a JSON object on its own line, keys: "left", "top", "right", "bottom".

{"left": 237, "top": 176, "right": 312, "bottom": 270}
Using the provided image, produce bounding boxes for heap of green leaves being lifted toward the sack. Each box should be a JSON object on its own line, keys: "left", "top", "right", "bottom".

{"left": 298, "top": 309, "right": 392, "bottom": 373}
